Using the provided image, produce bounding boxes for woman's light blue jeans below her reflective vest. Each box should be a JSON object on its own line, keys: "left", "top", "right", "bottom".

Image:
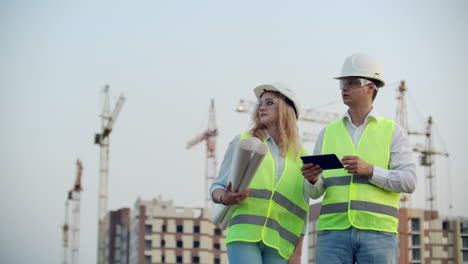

{"left": 227, "top": 241, "right": 288, "bottom": 264}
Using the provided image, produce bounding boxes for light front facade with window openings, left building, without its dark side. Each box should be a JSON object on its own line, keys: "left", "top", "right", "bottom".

{"left": 129, "top": 199, "right": 228, "bottom": 264}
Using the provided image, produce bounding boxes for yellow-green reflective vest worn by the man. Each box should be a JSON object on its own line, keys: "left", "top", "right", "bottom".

{"left": 318, "top": 117, "right": 400, "bottom": 233}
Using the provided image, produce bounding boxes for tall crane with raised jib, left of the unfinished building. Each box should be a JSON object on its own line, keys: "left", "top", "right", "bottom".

{"left": 94, "top": 85, "right": 125, "bottom": 264}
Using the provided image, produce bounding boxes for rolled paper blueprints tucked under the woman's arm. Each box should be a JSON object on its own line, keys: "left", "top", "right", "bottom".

{"left": 212, "top": 137, "right": 268, "bottom": 230}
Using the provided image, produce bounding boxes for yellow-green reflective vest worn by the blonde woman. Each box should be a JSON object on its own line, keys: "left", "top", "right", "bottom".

{"left": 226, "top": 134, "right": 309, "bottom": 259}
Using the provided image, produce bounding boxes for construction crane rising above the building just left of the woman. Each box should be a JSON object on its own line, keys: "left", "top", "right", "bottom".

{"left": 187, "top": 99, "right": 218, "bottom": 209}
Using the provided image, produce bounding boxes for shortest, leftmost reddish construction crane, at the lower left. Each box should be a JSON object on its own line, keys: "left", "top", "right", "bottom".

{"left": 62, "top": 159, "right": 83, "bottom": 264}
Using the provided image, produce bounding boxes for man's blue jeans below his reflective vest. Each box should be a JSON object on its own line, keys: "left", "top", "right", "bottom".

{"left": 315, "top": 227, "right": 398, "bottom": 264}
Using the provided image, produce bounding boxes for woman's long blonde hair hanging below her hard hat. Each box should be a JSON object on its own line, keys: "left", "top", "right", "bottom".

{"left": 249, "top": 92, "right": 302, "bottom": 158}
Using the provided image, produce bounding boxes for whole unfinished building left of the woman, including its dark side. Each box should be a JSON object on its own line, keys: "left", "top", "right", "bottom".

{"left": 104, "top": 199, "right": 229, "bottom": 264}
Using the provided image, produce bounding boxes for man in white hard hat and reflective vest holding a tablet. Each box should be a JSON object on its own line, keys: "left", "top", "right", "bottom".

{"left": 301, "top": 53, "right": 416, "bottom": 264}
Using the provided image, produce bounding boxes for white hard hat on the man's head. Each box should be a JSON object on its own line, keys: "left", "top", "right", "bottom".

{"left": 335, "top": 53, "right": 385, "bottom": 88}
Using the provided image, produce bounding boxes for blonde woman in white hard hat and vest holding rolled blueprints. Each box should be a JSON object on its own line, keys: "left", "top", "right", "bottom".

{"left": 210, "top": 83, "right": 309, "bottom": 264}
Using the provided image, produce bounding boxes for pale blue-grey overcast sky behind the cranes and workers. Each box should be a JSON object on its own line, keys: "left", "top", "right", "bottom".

{"left": 0, "top": 0, "right": 468, "bottom": 264}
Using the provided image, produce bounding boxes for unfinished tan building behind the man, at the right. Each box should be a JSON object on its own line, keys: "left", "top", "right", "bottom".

{"left": 307, "top": 203, "right": 468, "bottom": 264}
